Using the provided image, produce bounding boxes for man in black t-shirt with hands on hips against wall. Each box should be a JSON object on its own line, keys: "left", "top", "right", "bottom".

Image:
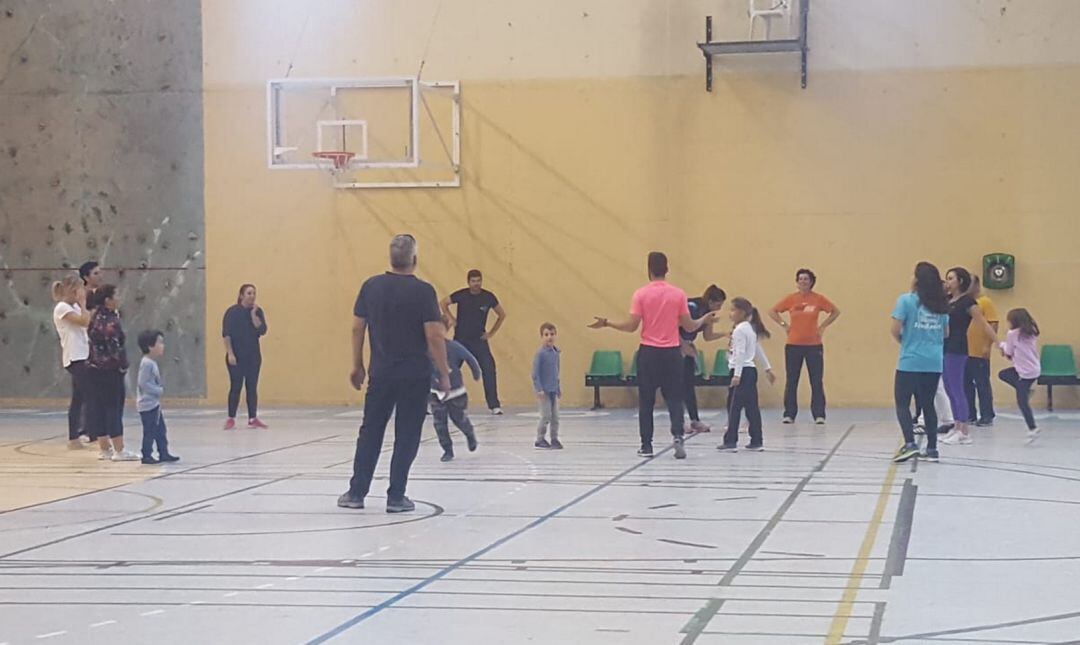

{"left": 441, "top": 269, "right": 507, "bottom": 415}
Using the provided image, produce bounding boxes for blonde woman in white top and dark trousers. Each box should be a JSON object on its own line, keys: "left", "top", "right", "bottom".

{"left": 52, "top": 276, "right": 93, "bottom": 449}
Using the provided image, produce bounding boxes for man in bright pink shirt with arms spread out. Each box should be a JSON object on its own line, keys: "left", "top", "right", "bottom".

{"left": 589, "top": 251, "right": 715, "bottom": 459}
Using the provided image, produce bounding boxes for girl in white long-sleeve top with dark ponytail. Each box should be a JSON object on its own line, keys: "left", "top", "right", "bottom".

{"left": 717, "top": 298, "right": 777, "bottom": 453}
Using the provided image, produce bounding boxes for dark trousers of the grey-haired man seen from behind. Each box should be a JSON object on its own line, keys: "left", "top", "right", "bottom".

{"left": 349, "top": 373, "right": 431, "bottom": 500}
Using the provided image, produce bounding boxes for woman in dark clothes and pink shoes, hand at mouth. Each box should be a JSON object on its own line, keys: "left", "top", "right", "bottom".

{"left": 221, "top": 284, "right": 268, "bottom": 430}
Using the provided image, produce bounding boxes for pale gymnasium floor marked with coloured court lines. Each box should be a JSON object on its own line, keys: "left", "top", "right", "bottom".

{"left": 0, "top": 408, "right": 1080, "bottom": 645}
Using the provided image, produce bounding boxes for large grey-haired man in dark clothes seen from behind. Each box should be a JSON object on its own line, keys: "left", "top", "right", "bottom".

{"left": 338, "top": 236, "right": 450, "bottom": 513}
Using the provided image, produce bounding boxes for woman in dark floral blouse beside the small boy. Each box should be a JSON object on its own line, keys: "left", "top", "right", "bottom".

{"left": 86, "top": 284, "right": 139, "bottom": 461}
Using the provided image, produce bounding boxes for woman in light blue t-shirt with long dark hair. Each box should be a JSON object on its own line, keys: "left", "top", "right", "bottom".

{"left": 892, "top": 263, "right": 948, "bottom": 462}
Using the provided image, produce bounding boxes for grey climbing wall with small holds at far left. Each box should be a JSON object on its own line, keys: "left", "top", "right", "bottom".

{"left": 0, "top": 0, "right": 206, "bottom": 399}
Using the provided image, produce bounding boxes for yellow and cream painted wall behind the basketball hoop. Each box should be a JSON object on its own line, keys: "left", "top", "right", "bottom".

{"left": 203, "top": 0, "right": 1080, "bottom": 405}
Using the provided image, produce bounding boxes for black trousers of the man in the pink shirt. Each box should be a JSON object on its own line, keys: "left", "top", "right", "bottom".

{"left": 637, "top": 345, "right": 684, "bottom": 447}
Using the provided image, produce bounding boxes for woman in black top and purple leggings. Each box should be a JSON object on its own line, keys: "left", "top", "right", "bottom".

{"left": 942, "top": 267, "right": 997, "bottom": 445}
